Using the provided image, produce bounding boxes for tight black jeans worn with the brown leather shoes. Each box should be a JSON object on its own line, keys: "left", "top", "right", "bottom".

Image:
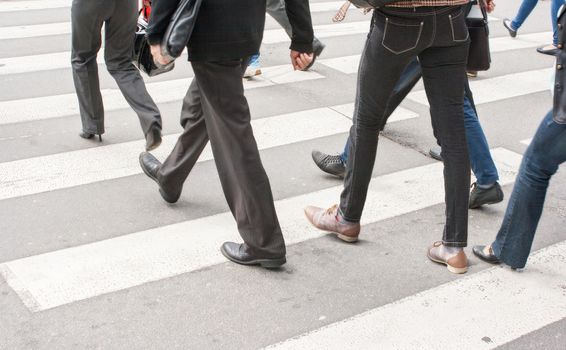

{"left": 340, "top": 6, "right": 470, "bottom": 247}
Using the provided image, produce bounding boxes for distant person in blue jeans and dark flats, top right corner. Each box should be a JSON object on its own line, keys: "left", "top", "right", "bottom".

{"left": 503, "top": 0, "right": 564, "bottom": 55}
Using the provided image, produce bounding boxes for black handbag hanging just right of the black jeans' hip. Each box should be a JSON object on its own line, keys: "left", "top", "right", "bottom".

{"left": 466, "top": 5, "right": 491, "bottom": 71}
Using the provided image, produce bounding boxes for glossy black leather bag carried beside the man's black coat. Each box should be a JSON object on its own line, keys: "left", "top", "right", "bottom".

{"left": 161, "top": 0, "right": 202, "bottom": 60}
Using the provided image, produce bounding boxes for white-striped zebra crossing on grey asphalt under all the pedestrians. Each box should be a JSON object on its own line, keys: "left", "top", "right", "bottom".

{"left": 0, "top": 0, "right": 566, "bottom": 349}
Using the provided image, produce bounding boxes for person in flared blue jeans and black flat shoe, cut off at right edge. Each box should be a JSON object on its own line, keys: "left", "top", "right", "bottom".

{"left": 473, "top": 6, "right": 566, "bottom": 269}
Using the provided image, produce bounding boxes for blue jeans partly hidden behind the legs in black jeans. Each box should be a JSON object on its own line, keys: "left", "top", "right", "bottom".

{"left": 340, "top": 60, "right": 499, "bottom": 186}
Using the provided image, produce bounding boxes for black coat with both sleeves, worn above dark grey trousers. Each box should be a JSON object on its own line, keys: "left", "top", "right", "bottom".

{"left": 147, "top": 0, "right": 313, "bottom": 61}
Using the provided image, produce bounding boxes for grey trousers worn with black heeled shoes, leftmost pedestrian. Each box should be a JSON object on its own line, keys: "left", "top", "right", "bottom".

{"left": 71, "top": 0, "right": 161, "bottom": 135}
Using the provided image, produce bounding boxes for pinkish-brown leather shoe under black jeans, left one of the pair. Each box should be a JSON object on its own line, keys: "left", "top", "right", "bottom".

{"left": 305, "top": 204, "right": 360, "bottom": 243}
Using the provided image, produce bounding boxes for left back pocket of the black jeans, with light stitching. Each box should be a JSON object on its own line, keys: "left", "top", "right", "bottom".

{"left": 381, "top": 17, "right": 424, "bottom": 55}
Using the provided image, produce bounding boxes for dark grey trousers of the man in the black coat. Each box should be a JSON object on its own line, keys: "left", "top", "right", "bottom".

{"left": 157, "top": 59, "right": 285, "bottom": 258}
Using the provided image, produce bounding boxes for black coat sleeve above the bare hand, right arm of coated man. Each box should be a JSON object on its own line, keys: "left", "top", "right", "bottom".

{"left": 286, "top": 0, "right": 314, "bottom": 53}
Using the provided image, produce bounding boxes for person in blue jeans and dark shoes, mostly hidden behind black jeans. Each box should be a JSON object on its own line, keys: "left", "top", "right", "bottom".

{"left": 312, "top": 59, "right": 504, "bottom": 209}
